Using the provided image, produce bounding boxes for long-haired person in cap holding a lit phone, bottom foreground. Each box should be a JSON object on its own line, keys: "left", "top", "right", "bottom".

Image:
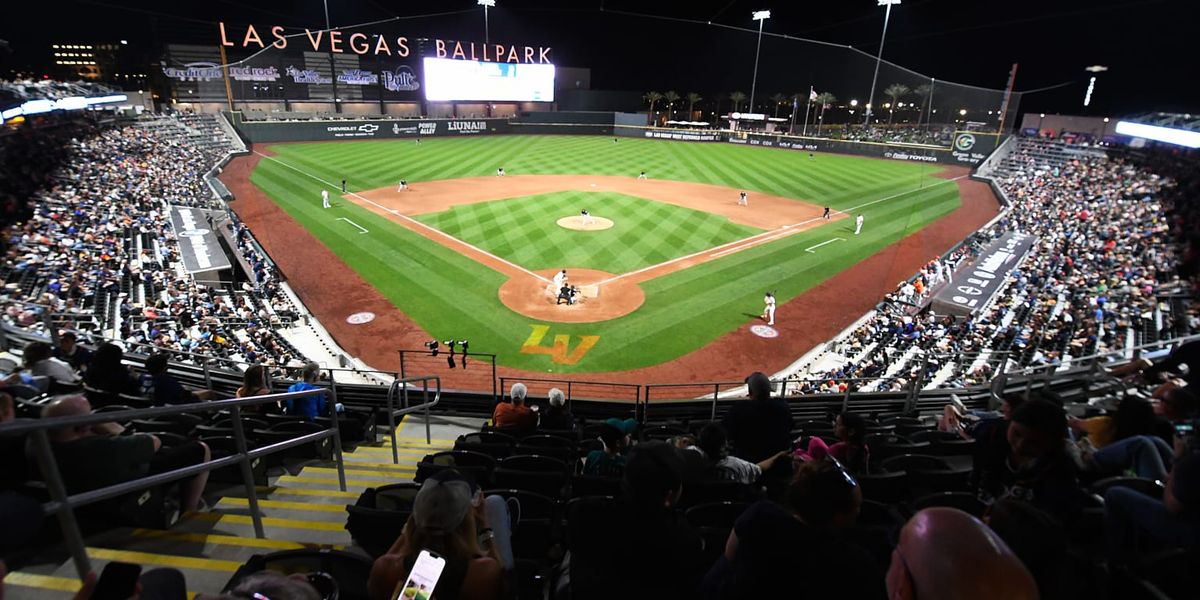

{"left": 367, "top": 469, "right": 514, "bottom": 600}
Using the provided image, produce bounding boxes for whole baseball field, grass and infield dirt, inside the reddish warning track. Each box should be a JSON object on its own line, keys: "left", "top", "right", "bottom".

{"left": 235, "top": 136, "right": 960, "bottom": 373}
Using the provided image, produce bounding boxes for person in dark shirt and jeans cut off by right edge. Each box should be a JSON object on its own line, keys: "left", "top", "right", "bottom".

{"left": 1104, "top": 451, "right": 1200, "bottom": 563}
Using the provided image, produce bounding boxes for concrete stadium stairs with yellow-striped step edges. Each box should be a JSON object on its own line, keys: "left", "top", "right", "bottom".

{"left": 5, "top": 416, "right": 481, "bottom": 599}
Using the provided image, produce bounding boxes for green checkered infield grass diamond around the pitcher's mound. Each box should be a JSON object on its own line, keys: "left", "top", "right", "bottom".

{"left": 416, "top": 191, "right": 762, "bottom": 274}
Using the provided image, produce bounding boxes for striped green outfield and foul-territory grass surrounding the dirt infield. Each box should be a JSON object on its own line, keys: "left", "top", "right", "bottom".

{"left": 251, "top": 136, "right": 959, "bottom": 372}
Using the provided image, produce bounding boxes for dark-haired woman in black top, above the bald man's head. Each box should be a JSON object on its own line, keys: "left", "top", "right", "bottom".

{"left": 980, "top": 398, "right": 1082, "bottom": 524}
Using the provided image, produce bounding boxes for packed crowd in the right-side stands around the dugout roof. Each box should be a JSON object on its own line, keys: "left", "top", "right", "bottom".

{"left": 798, "top": 140, "right": 1200, "bottom": 392}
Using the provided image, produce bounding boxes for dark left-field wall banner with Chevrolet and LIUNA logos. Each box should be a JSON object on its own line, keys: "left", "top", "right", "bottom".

{"left": 236, "top": 119, "right": 509, "bottom": 143}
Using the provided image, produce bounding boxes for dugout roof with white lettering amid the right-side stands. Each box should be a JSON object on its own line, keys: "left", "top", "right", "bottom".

{"left": 930, "top": 232, "right": 1038, "bottom": 317}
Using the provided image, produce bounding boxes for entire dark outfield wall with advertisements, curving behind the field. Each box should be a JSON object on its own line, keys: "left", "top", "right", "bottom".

{"left": 234, "top": 112, "right": 1002, "bottom": 166}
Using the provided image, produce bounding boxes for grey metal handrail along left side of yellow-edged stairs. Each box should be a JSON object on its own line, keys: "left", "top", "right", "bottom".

{"left": 0, "top": 390, "right": 346, "bottom": 580}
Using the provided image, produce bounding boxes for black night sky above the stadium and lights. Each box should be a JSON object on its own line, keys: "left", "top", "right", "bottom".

{"left": 0, "top": 0, "right": 1200, "bottom": 116}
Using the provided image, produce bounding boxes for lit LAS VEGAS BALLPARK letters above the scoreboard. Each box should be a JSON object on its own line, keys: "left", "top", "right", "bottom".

{"left": 217, "top": 22, "right": 551, "bottom": 64}
